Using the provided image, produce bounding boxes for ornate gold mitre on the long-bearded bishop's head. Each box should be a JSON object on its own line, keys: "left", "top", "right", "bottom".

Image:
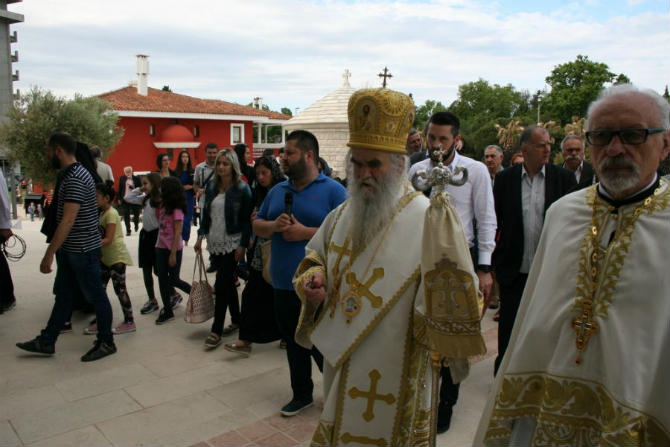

{"left": 347, "top": 88, "right": 414, "bottom": 154}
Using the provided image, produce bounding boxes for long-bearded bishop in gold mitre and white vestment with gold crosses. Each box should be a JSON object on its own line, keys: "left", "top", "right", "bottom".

{"left": 294, "top": 88, "right": 485, "bottom": 446}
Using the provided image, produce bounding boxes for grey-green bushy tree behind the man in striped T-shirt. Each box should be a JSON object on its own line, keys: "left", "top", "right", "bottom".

{"left": 0, "top": 87, "right": 123, "bottom": 184}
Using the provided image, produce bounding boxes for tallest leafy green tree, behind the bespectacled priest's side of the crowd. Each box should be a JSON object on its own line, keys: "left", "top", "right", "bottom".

{"left": 542, "top": 54, "right": 630, "bottom": 125}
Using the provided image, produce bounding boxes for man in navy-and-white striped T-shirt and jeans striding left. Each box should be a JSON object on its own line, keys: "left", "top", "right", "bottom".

{"left": 16, "top": 132, "right": 116, "bottom": 362}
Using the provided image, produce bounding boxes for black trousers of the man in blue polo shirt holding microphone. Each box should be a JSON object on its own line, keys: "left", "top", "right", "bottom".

{"left": 274, "top": 289, "right": 323, "bottom": 400}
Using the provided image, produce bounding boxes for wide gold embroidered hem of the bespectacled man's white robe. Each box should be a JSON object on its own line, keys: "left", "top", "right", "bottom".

{"left": 484, "top": 373, "right": 670, "bottom": 446}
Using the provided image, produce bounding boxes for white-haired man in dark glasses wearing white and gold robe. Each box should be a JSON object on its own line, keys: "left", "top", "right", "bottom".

{"left": 474, "top": 84, "right": 670, "bottom": 445}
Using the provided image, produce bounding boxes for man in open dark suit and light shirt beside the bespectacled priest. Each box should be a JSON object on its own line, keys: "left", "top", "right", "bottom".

{"left": 493, "top": 125, "right": 577, "bottom": 372}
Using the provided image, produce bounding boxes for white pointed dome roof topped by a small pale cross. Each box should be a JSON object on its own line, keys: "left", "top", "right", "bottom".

{"left": 284, "top": 70, "right": 356, "bottom": 130}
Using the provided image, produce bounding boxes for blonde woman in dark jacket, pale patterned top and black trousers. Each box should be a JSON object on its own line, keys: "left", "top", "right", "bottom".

{"left": 194, "top": 150, "right": 252, "bottom": 349}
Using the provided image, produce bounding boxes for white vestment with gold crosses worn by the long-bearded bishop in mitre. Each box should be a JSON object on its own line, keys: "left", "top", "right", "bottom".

{"left": 294, "top": 189, "right": 483, "bottom": 446}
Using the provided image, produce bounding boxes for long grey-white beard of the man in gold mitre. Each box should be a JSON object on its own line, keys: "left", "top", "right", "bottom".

{"left": 347, "top": 158, "right": 405, "bottom": 250}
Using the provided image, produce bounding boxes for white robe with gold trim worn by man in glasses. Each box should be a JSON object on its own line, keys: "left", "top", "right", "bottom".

{"left": 474, "top": 181, "right": 670, "bottom": 446}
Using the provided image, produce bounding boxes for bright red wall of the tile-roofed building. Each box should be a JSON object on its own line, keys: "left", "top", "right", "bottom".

{"left": 105, "top": 117, "right": 253, "bottom": 180}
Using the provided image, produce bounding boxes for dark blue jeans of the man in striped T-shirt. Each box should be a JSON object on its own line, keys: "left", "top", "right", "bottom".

{"left": 40, "top": 248, "right": 114, "bottom": 344}
